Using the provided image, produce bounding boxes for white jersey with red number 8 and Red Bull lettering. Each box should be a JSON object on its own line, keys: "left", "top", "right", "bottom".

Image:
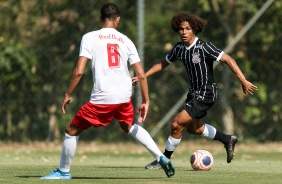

{"left": 79, "top": 28, "right": 140, "bottom": 104}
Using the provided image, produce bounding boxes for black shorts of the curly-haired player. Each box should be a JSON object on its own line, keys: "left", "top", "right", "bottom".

{"left": 183, "top": 94, "right": 214, "bottom": 119}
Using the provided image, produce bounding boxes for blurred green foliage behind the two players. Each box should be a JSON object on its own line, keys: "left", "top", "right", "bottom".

{"left": 0, "top": 0, "right": 282, "bottom": 142}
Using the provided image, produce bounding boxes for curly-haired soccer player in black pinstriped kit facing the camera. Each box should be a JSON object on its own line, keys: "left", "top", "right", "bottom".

{"left": 132, "top": 12, "right": 258, "bottom": 169}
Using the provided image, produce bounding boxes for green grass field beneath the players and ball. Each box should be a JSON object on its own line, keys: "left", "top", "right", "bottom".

{"left": 0, "top": 141, "right": 282, "bottom": 184}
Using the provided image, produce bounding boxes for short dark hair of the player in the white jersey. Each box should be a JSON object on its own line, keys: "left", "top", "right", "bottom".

{"left": 100, "top": 3, "right": 120, "bottom": 21}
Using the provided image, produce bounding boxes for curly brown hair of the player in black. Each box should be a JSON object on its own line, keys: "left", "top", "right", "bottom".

{"left": 170, "top": 11, "right": 208, "bottom": 35}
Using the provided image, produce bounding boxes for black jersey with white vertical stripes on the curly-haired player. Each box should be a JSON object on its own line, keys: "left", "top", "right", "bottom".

{"left": 166, "top": 38, "right": 223, "bottom": 102}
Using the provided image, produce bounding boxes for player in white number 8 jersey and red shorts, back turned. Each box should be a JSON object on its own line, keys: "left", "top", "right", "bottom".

{"left": 41, "top": 3, "right": 174, "bottom": 179}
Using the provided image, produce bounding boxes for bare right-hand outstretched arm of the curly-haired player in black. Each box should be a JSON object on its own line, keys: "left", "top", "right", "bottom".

{"left": 220, "top": 53, "right": 258, "bottom": 95}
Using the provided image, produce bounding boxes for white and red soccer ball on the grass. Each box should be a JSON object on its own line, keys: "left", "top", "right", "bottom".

{"left": 190, "top": 150, "right": 213, "bottom": 171}
